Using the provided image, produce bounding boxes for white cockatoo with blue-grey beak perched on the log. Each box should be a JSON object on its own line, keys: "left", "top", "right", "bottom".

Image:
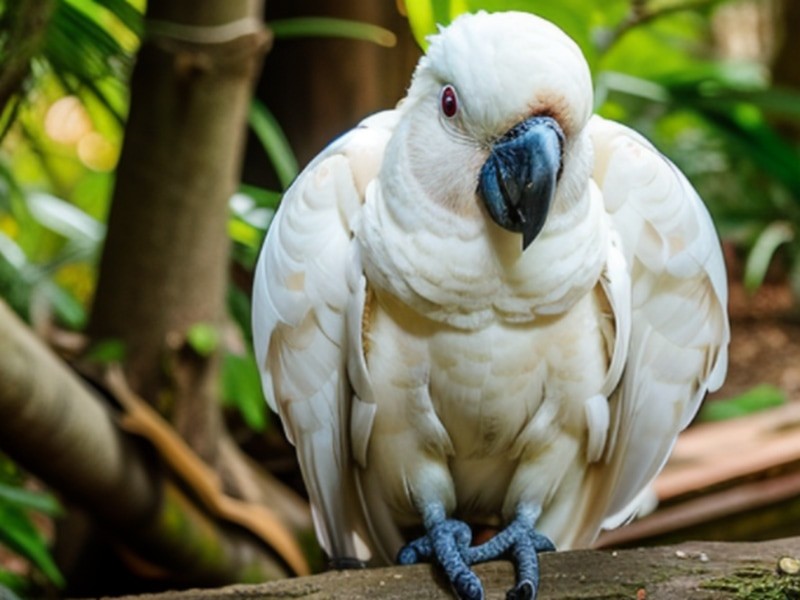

{"left": 253, "top": 12, "right": 729, "bottom": 598}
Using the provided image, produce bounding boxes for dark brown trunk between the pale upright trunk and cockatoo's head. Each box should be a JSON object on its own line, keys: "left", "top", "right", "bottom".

{"left": 245, "top": 0, "right": 420, "bottom": 188}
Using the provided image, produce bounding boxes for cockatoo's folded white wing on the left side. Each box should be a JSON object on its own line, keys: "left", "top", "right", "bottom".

{"left": 253, "top": 112, "right": 395, "bottom": 560}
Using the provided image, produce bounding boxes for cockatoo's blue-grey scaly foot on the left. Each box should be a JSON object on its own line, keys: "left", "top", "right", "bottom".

{"left": 397, "top": 503, "right": 483, "bottom": 600}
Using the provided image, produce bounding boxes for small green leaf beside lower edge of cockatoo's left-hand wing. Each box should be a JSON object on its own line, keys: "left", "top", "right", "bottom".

{"left": 222, "top": 354, "right": 267, "bottom": 431}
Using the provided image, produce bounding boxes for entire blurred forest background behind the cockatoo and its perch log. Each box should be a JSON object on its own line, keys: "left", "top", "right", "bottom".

{"left": 0, "top": 0, "right": 800, "bottom": 598}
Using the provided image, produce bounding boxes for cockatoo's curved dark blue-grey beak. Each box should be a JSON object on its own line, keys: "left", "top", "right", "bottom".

{"left": 478, "top": 116, "right": 564, "bottom": 250}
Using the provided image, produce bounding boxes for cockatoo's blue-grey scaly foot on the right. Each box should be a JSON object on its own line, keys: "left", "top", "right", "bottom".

{"left": 466, "top": 504, "right": 556, "bottom": 600}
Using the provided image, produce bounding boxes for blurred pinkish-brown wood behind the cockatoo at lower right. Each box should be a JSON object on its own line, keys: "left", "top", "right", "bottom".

{"left": 597, "top": 402, "right": 800, "bottom": 548}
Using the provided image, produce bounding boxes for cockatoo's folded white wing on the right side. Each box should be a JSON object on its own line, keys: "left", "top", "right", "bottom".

{"left": 590, "top": 117, "right": 729, "bottom": 526}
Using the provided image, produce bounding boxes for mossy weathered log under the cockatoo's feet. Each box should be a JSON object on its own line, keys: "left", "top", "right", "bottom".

{"left": 95, "top": 538, "right": 800, "bottom": 600}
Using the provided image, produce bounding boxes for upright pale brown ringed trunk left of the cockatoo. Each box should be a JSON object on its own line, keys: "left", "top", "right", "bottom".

{"left": 89, "top": 0, "right": 268, "bottom": 464}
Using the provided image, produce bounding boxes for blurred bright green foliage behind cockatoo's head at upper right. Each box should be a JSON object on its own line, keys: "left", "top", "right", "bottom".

{"left": 406, "top": 0, "right": 800, "bottom": 295}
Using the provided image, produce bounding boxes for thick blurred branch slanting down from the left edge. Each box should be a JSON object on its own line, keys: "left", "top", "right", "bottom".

{"left": 0, "top": 302, "right": 286, "bottom": 585}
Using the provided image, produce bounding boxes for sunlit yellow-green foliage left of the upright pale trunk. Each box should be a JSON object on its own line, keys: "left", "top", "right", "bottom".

{"left": 0, "top": 0, "right": 142, "bottom": 329}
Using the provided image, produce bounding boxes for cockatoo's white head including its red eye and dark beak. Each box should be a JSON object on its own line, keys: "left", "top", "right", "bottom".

{"left": 401, "top": 12, "right": 593, "bottom": 249}
